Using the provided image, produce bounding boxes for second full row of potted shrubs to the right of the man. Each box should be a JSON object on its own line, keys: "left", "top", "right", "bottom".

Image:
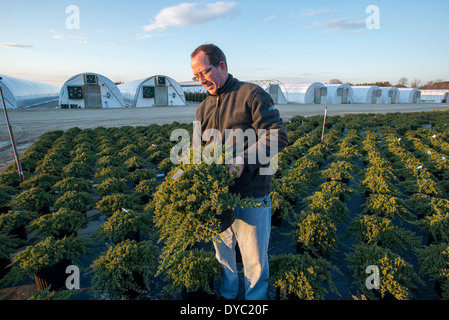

{"left": 346, "top": 130, "right": 422, "bottom": 300}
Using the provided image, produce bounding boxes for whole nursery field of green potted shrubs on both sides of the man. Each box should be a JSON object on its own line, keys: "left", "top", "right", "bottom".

{"left": 0, "top": 111, "right": 449, "bottom": 300}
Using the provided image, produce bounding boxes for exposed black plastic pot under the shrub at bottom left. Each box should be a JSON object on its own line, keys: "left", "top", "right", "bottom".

{"left": 34, "top": 259, "right": 72, "bottom": 291}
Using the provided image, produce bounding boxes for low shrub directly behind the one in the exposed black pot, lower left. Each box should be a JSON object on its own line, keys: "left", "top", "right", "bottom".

{"left": 30, "top": 208, "right": 88, "bottom": 239}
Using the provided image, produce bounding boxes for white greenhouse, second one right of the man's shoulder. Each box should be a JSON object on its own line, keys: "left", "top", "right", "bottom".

{"left": 285, "top": 82, "right": 328, "bottom": 104}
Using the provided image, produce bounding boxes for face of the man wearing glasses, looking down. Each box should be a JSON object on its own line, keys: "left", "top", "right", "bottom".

{"left": 190, "top": 51, "right": 228, "bottom": 95}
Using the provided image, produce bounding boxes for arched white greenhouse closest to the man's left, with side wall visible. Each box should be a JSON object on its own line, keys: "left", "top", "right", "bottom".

{"left": 118, "top": 75, "right": 186, "bottom": 107}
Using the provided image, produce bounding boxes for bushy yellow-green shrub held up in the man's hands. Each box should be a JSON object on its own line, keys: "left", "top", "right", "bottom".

{"left": 151, "top": 147, "right": 262, "bottom": 270}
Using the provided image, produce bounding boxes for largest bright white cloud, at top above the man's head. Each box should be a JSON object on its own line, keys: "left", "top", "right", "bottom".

{"left": 143, "top": 1, "right": 238, "bottom": 32}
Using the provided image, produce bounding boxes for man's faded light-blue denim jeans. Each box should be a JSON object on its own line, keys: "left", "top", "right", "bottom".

{"left": 214, "top": 195, "right": 271, "bottom": 300}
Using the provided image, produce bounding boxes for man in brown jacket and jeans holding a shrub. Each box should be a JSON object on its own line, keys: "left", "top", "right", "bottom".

{"left": 191, "top": 44, "right": 288, "bottom": 300}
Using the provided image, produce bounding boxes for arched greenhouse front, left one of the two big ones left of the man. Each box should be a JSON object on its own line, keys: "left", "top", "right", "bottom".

{"left": 59, "top": 73, "right": 125, "bottom": 108}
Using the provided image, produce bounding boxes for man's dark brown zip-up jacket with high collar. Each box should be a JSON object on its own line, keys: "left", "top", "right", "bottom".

{"left": 196, "top": 75, "right": 288, "bottom": 198}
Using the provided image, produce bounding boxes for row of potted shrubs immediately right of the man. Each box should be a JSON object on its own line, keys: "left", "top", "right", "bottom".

{"left": 269, "top": 122, "right": 354, "bottom": 300}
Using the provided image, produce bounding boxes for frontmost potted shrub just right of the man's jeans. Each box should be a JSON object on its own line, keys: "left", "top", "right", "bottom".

{"left": 268, "top": 253, "right": 339, "bottom": 300}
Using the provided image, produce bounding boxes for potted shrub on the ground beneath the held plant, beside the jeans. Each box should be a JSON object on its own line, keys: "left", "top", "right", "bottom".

{"left": 165, "top": 248, "right": 222, "bottom": 300}
